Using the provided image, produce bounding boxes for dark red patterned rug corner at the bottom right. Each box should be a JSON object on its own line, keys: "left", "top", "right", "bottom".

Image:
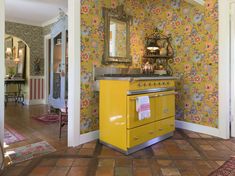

{"left": 209, "top": 157, "right": 235, "bottom": 176}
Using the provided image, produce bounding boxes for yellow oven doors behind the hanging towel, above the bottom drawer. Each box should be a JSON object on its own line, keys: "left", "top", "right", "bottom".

{"left": 127, "top": 91, "right": 176, "bottom": 129}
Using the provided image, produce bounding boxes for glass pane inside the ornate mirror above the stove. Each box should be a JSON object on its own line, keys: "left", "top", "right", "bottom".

{"left": 109, "top": 18, "right": 127, "bottom": 57}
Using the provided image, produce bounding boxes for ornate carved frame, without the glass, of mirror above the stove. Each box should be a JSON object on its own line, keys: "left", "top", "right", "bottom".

{"left": 103, "top": 5, "right": 132, "bottom": 64}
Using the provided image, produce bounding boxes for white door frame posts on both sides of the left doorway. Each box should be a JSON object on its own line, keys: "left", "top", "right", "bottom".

{"left": 0, "top": 0, "right": 81, "bottom": 146}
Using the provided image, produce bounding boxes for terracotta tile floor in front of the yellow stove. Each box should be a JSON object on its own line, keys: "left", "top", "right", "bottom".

{"left": 2, "top": 129, "right": 235, "bottom": 176}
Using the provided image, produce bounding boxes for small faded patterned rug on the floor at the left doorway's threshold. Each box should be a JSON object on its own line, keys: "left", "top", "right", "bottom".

{"left": 6, "top": 141, "right": 56, "bottom": 164}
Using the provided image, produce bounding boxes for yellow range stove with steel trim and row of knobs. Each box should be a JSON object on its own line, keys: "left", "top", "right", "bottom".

{"left": 99, "top": 76, "right": 176, "bottom": 154}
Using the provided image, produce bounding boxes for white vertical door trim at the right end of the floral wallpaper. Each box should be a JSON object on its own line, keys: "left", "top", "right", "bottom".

{"left": 218, "top": 0, "right": 230, "bottom": 139}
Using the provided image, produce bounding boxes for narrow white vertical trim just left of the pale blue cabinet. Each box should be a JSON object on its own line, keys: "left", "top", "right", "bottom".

{"left": 44, "top": 34, "right": 51, "bottom": 104}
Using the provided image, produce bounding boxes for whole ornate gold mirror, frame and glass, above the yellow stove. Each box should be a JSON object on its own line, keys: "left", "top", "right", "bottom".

{"left": 103, "top": 5, "right": 132, "bottom": 64}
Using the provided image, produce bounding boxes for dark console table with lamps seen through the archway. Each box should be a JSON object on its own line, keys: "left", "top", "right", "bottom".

{"left": 5, "top": 78, "right": 25, "bottom": 105}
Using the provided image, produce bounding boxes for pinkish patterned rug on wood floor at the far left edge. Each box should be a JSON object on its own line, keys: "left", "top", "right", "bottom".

{"left": 4, "top": 125, "right": 25, "bottom": 145}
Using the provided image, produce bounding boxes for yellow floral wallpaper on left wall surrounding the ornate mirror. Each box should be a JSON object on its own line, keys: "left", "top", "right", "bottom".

{"left": 81, "top": 0, "right": 152, "bottom": 133}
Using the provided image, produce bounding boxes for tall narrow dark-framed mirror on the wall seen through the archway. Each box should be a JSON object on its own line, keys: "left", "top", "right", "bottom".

{"left": 16, "top": 41, "right": 27, "bottom": 78}
